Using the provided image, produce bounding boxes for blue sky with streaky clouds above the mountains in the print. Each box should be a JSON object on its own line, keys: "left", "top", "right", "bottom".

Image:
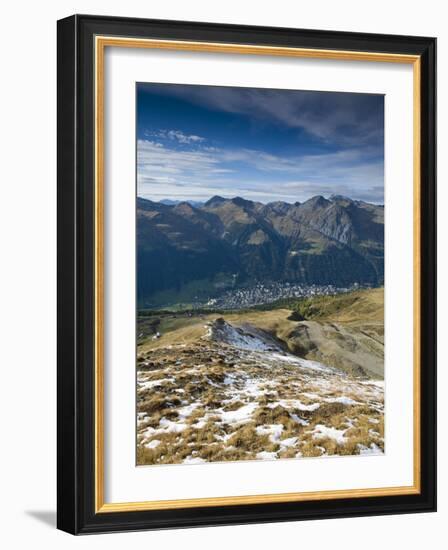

{"left": 137, "top": 83, "right": 384, "bottom": 203}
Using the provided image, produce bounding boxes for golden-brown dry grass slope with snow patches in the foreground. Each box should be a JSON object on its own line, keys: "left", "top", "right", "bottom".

{"left": 137, "top": 320, "right": 384, "bottom": 470}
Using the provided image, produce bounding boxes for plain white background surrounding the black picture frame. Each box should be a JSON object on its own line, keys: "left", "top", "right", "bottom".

{"left": 0, "top": 0, "right": 442, "bottom": 550}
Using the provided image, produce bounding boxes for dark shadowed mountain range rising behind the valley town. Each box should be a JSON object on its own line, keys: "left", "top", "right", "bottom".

{"left": 137, "top": 196, "right": 384, "bottom": 305}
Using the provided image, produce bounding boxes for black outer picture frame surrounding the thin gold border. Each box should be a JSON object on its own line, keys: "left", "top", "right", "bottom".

{"left": 57, "top": 15, "right": 436, "bottom": 534}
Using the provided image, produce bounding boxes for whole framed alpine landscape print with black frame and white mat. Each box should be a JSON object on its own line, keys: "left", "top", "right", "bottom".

{"left": 58, "top": 15, "right": 436, "bottom": 534}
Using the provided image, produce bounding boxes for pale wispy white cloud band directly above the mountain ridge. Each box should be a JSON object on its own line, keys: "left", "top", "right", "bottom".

{"left": 137, "top": 140, "right": 383, "bottom": 206}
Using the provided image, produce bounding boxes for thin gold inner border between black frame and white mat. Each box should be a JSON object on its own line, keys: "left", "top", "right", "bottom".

{"left": 94, "top": 36, "right": 421, "bottom": 513}
